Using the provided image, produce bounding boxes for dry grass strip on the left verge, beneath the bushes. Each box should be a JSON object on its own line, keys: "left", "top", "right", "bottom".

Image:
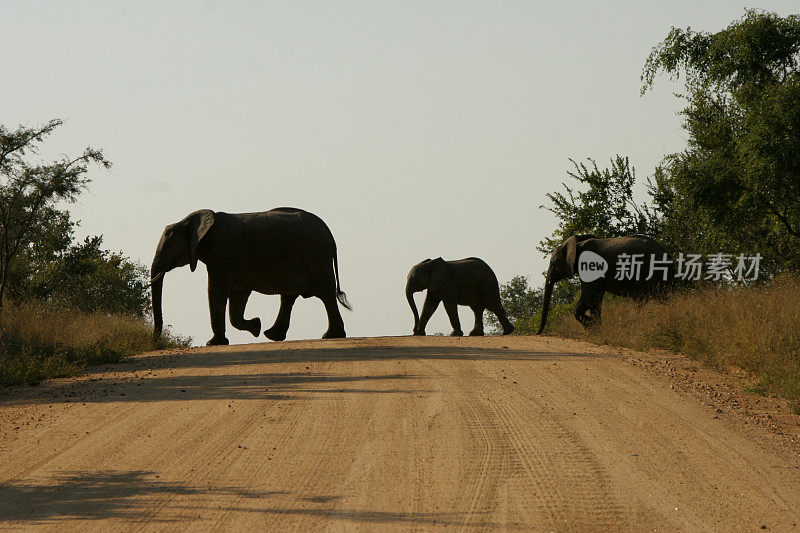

{"left": 0, "top": 302, "right": 191, "bottom": 385}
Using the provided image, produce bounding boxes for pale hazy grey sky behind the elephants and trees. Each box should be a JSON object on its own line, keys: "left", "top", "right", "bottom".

{"left": 0, "top": 0, "right": 798, "bottom": 344}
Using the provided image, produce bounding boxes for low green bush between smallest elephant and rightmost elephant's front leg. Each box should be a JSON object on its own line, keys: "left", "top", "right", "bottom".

{"left": 486, "top": 276, "right": 580, "bottom": 335}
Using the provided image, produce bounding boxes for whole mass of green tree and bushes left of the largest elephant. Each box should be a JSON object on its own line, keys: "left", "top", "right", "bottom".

{"left": 0, "top": 120, "right": 150, "bottom": 316}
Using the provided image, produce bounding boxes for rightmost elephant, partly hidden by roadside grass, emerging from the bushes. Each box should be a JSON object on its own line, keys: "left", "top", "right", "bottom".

{"left": 537, "top": 235, "right": 673, "bottom": 334}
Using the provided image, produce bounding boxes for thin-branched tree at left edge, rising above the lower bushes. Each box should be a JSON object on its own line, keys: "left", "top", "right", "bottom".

{"left": 0, "top": 120, "right": 111, "bottom": 307}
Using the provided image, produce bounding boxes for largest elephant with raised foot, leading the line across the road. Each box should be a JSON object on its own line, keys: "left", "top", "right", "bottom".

{"left": 150, "top": 207, "right": 350, "bottom": 346}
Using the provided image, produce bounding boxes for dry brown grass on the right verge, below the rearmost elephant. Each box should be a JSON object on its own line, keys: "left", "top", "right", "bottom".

{"left": 552, "top": 275, "right": 800, "bottom": 408}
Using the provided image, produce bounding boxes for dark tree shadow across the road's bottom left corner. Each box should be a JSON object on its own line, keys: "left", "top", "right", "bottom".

{"left": 0, "top": 471, "right": 488, "bottom": 527}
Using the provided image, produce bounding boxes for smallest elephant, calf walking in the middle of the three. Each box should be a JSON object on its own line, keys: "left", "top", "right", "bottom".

{"left": 406, "top": 257, "right": 514, "bottom": 337}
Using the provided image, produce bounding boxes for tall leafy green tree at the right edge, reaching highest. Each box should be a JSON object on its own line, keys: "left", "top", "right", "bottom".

{"left": 642, "top": 10, "right": 800, "bottom": 272}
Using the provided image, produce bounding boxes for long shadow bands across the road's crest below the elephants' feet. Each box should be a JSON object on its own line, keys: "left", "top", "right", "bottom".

{"left": 1, "top": 339, "right": 603, "bottom": 405}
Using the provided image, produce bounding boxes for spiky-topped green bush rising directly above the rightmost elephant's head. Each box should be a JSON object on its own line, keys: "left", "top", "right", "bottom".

{"left": 537, "top": 155, "right": 655, "bottom": 253}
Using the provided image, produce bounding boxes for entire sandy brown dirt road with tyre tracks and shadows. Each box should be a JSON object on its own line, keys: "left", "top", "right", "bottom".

{"left": 0, "top": 337, "right": 800, "bottom": 531}
